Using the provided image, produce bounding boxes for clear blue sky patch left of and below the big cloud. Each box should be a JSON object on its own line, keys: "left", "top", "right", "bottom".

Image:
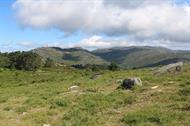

{"left": 0, "top": 0, "right": 87, "bottom": 52}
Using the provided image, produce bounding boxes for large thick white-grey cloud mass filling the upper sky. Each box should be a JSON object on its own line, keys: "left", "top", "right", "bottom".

{"left": 13, "top": 0, "right": 190, "bottom": 42}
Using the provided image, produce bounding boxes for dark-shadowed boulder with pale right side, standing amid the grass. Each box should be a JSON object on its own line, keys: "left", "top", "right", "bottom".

{"left": 121, "top": 78, "right": 142, "bottom": 89}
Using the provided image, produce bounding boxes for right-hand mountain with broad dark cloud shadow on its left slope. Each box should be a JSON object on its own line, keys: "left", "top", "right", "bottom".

{"left": 92, "top": 46, "right": 190, "bottom": 68}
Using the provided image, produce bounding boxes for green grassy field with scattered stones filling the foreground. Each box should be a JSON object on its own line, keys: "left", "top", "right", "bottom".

{"left": 0, "top": 66, "right": 190, "bottom": 126}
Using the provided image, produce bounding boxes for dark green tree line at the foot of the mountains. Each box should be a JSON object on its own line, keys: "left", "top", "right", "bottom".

{"left": 0, "top": 51, "right": 119, "bottom": 71}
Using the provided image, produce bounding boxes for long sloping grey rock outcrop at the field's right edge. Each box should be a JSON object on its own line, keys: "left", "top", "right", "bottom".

{"left": 154, "top": 62, "right": 183, "bottom": 75}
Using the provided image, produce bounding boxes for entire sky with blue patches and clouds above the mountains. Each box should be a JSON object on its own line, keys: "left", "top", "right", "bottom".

{"left": 0, "top": 0, "right": 190, "bottom": 52}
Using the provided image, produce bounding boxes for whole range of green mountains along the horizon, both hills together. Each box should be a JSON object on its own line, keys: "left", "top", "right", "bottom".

{"left": 33, "top": 46, "right": 190, "bottom": 68}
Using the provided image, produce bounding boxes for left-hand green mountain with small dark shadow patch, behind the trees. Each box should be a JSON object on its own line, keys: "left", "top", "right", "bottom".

{"left": 32, "top": 47, "right": 108, "bottom": 65}
